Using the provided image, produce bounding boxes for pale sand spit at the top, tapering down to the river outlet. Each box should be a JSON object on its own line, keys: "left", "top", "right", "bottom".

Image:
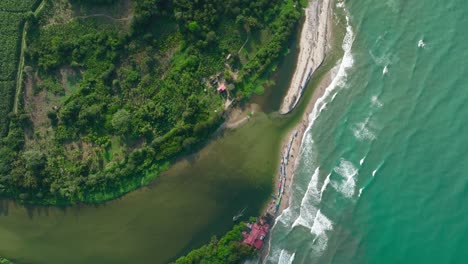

{"left": 280, "top": 0, "right": 333, "bottom": 114}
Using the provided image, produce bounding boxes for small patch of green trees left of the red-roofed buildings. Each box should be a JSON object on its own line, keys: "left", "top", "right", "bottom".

{"left": 174, "top": 223, "right": 255, "bottom": 264}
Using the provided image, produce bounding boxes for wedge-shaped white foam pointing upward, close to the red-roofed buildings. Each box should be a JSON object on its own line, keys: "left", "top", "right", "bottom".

{"left": 292, "top": 167, "right": 319, "bottom": 229}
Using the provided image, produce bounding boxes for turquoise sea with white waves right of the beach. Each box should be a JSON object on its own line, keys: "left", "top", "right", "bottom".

{"left": 267, "top": 0, "right": 468, "bottom": 263}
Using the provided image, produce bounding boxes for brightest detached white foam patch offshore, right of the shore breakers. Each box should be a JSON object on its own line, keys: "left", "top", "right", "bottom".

{"left": 332, "top": 159, "right": 358, "bottom": 198}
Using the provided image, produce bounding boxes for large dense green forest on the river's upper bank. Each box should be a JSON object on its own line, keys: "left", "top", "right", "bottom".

{"left": 0, "top": 0, "right": 301, "bottom": 204}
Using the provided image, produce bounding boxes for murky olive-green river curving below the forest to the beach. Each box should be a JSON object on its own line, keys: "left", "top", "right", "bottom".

{"left": 0, "top": 6, "right": 348, "bottom": 264}
